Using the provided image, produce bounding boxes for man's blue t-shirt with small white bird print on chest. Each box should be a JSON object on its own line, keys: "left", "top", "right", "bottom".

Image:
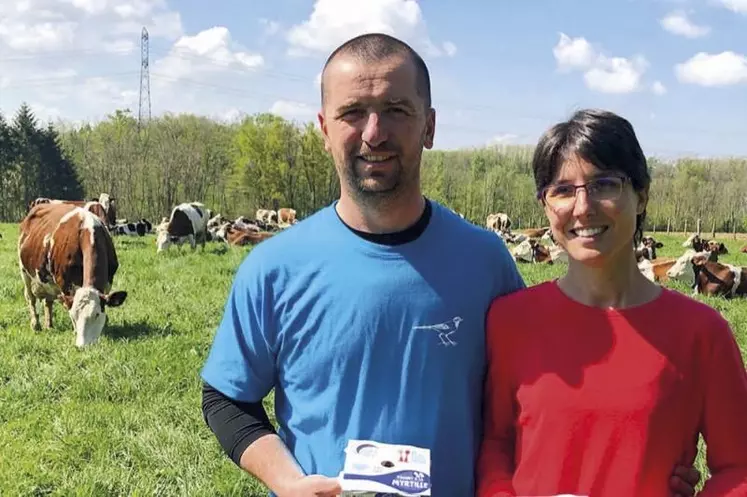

{"left": 202, "top": 202, "right": 524, "bottom": 497}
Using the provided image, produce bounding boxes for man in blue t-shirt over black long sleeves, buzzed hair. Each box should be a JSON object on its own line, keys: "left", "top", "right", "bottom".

{"left": 202, "top": 34, "right": 700, "bottom": 497}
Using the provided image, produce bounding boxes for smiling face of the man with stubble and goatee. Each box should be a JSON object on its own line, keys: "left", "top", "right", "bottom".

{"left": 319, "top": 55, "right": 435, "bottom": 201}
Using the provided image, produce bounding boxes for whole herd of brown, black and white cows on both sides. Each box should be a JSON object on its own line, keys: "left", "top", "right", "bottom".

{"left": 5, "top": 193, "right": 747, "bottom": 347}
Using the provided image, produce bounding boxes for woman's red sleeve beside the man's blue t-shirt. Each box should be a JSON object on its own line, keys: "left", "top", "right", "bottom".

{"left": 476, "top": 298, "right": 517, "bottom": 497}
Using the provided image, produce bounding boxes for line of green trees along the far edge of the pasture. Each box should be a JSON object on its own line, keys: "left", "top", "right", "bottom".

{"left": 0, "top": 105, "right": 747, "bottom": 232}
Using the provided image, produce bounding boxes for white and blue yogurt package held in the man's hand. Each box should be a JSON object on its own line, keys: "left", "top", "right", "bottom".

{"left": 339, "top": 440, "right": 431, "bottom": 497}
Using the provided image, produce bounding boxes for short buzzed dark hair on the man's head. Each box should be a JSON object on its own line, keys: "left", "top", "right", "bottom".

{"left": 321, "top": 33, "right": 431, "bottom": 109}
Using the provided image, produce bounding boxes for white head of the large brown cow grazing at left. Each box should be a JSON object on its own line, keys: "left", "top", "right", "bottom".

{"left": 60, "top": 287, "right": 127, "bottom": 347}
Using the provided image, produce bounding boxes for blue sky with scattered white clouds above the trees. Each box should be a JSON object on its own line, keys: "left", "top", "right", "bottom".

{"left": 0, "top": 0, "right": 747, "bottom": 157}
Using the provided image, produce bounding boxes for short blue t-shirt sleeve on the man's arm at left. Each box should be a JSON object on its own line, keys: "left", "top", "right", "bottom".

{"left": 201, "top": 250, "right": 276, "bottom": 402}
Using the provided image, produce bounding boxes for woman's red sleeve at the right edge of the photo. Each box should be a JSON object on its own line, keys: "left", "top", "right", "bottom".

{"left": 698, "top": 321, "right": 747, "bottom": 497}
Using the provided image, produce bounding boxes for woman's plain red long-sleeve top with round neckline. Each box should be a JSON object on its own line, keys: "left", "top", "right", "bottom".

{"left": 477, "top": 281, "right": 747, "bottom": 497}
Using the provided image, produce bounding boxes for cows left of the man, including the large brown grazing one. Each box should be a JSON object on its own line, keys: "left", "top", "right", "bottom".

{"left": 13, "top": 193, "right": 296, "bottom": 347}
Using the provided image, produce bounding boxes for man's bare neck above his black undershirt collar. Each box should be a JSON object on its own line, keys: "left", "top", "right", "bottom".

{"left": 337, "top": 194, "right": 425, "bottom": 233}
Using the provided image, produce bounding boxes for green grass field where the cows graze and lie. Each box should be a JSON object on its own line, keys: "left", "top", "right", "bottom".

{"left": 0, "top": 224, "right": 747, "bottom": 496}
